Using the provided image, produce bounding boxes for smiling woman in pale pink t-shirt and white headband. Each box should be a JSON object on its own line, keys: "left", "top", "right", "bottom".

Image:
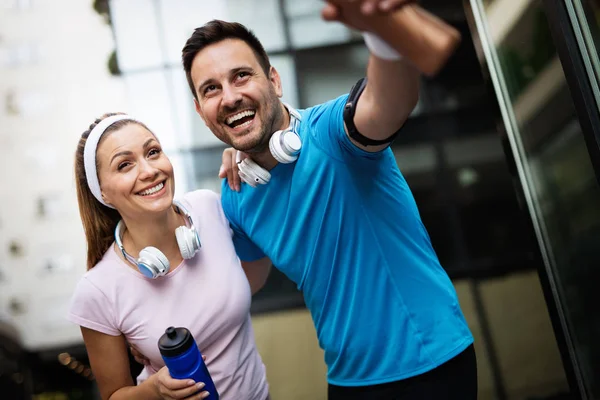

{"left": 69, "top": 114, "right": 268, "bottom": 400}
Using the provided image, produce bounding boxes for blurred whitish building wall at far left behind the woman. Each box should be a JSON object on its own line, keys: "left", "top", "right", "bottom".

{"left": 0, "top": 0, "right": 126, "bottom": 350}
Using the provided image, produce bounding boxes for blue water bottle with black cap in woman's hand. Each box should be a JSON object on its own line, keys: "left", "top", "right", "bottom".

{"left": 158, "top": 326, "right": 219, "bottom": 400}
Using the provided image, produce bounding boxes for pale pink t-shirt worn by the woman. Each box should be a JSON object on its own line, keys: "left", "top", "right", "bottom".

{"left": 68, "top": 190, "right": 269, "bottom": 400}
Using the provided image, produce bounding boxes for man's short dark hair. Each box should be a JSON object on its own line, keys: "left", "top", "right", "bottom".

{"left": 181, "top": 19, "right": 271, "bottom": 100}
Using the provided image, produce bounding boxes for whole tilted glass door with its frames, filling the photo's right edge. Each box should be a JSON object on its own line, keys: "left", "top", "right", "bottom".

{"left": 465, "top": 0, "right": 600, "bottom": 399}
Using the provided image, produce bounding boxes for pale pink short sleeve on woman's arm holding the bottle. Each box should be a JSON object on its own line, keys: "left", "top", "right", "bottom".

{"left": 67, "top": 276, "right": 121, "bottom": 336}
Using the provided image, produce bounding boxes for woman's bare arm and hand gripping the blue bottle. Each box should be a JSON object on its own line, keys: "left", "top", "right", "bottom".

{"left": 81, "top": 327, "right": 207, "bottom": 400}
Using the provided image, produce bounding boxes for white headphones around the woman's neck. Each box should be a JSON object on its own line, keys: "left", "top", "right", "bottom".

{"left": 115, "top": 201, "right": 201, "bottom": 279}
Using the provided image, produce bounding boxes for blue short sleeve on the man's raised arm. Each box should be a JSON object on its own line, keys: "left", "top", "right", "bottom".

{"left": 302, "top": 94, "right": 387, "bottom": 159}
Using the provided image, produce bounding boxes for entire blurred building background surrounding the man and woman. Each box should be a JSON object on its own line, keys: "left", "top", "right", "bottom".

{"left": 0, "top": 0, "right": 600, "bottom": 400}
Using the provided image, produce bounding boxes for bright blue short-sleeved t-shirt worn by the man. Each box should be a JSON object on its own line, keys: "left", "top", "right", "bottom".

{"left": 222, "top": 95, "right": 473, "bottom": 386}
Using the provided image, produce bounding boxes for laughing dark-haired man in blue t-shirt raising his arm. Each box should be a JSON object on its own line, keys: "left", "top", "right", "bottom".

{"left": 182, "top": 1, "right": 477, "bottom": 400}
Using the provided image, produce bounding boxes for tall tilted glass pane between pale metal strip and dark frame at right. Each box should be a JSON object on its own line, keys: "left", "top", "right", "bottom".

{"left": 471, "top": 0, "right": 600, "bottom": 398}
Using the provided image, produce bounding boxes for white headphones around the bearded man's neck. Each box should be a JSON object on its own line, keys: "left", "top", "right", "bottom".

{"left": 235, "top": 103, "right": 302, "bottom": 187}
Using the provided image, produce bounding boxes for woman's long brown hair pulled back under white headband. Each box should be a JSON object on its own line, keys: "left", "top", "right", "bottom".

{"left": 75, "top": 113, "right": 147, "bottom": 269}
